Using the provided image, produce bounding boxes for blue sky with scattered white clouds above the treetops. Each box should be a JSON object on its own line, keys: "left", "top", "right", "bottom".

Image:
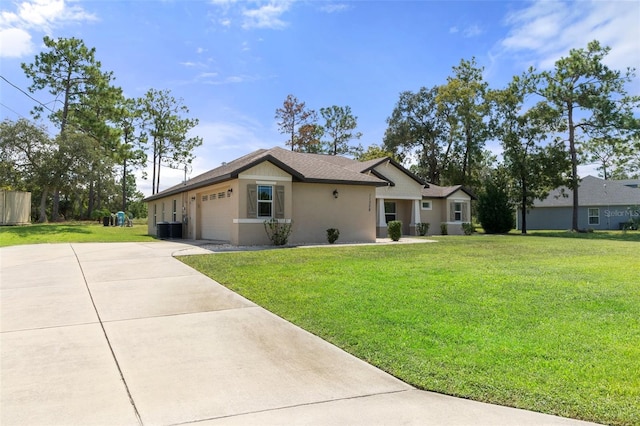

{"left": 0, "top": 0, "right": 640, "bottom": 195}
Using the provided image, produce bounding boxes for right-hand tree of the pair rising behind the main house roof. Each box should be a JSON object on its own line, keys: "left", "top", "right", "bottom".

{"left": 320, "top": 105, "right": 362, "bottom": 155}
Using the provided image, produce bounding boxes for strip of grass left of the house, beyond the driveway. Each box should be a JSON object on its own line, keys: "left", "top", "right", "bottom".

{"left": 0, "top": 222, "right": 155, "bottom": 247}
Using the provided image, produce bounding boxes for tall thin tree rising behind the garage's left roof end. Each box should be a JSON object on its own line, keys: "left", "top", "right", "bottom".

{"left": 140, "top": 89, "right": 202, "bottom": 194}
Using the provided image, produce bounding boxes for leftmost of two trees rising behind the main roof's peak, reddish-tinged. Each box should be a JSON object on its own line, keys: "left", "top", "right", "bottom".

{"left": 275, "top": 95, "right": 318, "bottom": 152}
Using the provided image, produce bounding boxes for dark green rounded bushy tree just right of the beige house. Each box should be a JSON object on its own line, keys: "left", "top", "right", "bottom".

{"left": 477, "top": 171, "right": 514, "bottom": 234}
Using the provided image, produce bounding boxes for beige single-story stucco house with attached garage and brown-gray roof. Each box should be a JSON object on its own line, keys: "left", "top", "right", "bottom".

{"left": 145, "top": 147, "right": 474, "bottom": 246}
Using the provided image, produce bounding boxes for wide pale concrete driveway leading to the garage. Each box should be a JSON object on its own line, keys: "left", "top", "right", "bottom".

{"left": 0, "top": 242, "right": 600, "bottom": 426}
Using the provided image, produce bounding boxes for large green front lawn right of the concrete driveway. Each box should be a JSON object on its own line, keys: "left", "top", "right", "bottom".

{"left": 181, "top": 235, "right": 640, "bottom": 425}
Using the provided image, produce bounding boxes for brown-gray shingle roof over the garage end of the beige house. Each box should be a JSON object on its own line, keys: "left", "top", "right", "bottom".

{"left": 144, "top": 147, "right": 387, "bottom": 201}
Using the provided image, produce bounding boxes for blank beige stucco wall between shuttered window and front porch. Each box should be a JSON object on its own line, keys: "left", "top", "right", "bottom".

{"left": 290, "top": 182, "right": 376, "bottom": 244}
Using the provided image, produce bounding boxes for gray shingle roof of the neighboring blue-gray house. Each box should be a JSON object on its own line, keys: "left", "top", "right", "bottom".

{"left": 534, "top": 176, "right": 640, "bottom": 207}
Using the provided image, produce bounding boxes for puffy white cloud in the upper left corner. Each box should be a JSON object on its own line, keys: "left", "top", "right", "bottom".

{"left": 0, "top": 0, "right": 97, "bottom": 57}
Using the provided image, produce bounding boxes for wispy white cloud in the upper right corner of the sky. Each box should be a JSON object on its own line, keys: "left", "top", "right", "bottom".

{"left": 500, "top": 0, "right": 640, "bottom": 73}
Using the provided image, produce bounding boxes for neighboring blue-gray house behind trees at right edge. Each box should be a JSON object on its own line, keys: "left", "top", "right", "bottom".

{"left": 516, "top": 176, "right": 640, "bottom": 230}
